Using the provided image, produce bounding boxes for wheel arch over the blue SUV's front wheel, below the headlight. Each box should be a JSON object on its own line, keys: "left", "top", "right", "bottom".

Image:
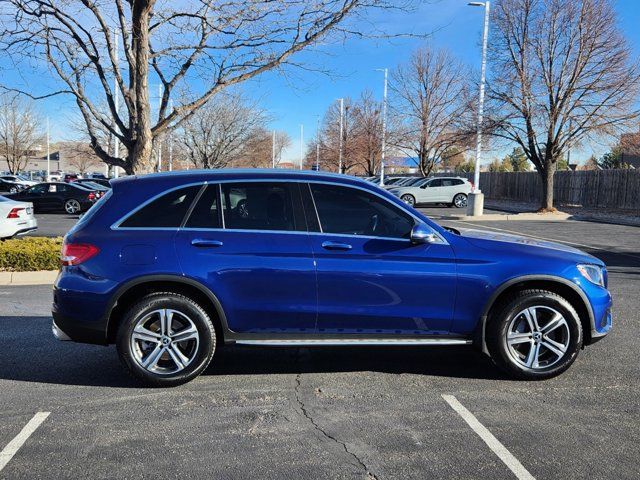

{"left": 474, "top": 275, "right": 595, "bottom": 353}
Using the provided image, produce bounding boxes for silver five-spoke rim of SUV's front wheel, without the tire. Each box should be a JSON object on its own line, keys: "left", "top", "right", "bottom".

{"left": 506, "top": 305, "right": 571, "bottom": 371}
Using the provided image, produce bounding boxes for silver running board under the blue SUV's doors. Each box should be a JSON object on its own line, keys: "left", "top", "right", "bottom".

{"left": 234, "top": 338, "right": 472, "bottom": 347}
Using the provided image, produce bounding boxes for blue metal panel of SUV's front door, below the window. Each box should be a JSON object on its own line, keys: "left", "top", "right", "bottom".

{"left": 312, "top": 235, "right": 456, "bottom": 335}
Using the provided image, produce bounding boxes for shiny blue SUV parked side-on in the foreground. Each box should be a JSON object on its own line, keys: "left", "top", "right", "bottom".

{"left": 53, "top": 170, "right": 611, "bottom": 386}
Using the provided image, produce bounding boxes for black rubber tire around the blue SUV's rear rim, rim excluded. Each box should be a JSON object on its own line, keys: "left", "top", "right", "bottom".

{"left": 116, "top": 292, "right": 216, "bottom": 387}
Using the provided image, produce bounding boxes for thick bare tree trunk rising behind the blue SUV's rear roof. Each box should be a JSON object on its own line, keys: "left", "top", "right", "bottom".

{"left": 125, "top": 0, "right": 155, "bottom": 173}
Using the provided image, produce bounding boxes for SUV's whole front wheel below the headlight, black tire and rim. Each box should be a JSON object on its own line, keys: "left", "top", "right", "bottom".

{"left": 486, "top": 289, "right": 583, "bottom": 380}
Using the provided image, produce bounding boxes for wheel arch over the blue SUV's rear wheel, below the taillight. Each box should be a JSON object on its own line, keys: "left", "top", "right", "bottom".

{"left": 105, "top": 275, "right": 229, "bottom": 344}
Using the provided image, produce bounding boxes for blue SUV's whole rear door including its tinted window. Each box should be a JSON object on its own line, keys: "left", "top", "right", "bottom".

{"left": 176, "top": 181, "right": 317, "bottom": 336}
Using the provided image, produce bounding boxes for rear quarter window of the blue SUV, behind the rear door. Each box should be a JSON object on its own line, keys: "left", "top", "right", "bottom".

{"left": 120, "top": 185, "right": 200, "bottom": 228}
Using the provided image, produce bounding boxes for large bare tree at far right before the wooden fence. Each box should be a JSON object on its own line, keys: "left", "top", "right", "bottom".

{"left": 489, "top": 0, "right": 640, "bottom": 210}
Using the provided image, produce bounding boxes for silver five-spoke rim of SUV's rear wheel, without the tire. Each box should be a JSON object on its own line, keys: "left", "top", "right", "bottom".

{"left": 130, "top": 308, "right": 200, "bottom": 375}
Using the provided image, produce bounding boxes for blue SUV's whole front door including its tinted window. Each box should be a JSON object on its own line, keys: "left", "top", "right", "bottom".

{"left": 307, "top": 183, "right": 456, "bottom": 336}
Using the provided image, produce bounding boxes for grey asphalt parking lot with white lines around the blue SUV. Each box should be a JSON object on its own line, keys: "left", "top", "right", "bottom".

{"left": 0, "top": 212, "right": 640, "bottom": 479}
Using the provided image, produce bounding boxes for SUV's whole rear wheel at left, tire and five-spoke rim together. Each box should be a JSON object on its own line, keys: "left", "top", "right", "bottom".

{"left": 116, "top": 293, "right": 216, "bottom": 387}
